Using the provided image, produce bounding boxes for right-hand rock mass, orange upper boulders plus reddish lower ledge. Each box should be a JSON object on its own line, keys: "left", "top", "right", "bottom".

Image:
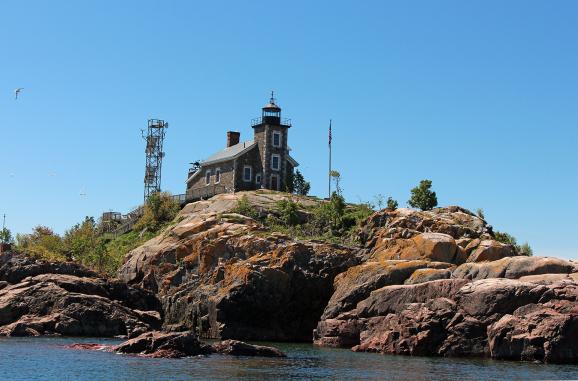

{"left": 314, "top": 207, "right": 578, "bottom": 362}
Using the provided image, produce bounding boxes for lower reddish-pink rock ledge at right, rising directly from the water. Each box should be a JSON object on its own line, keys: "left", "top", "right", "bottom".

{"left": 315, "top": 279, "right": 578, "bottom": 362}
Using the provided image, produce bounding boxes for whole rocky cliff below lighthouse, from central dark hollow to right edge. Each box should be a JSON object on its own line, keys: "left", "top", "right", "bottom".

{"left": 119, "top": 192, "right": 578, "bottom": 362}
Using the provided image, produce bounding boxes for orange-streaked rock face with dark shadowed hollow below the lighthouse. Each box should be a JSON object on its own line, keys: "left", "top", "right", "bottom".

{"left": 119, "top": 192, "right": 359, "bottom": 341}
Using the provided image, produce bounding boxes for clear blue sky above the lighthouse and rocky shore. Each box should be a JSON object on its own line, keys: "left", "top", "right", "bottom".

{"left": 0, "top": 0, "right": 578, "bottom": 258}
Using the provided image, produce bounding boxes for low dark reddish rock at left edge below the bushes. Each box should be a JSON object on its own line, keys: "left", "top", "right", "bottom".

{"left": 0, "top": 253, "right": 161, "bottom": 336}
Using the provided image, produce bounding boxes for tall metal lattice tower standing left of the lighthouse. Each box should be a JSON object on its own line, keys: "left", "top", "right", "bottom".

{"left": 143, "top": 119, "right": 169, "bottom": 202}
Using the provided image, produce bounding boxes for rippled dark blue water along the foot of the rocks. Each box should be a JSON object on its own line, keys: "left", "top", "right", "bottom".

{"left": 0, "top": 338, "right": 578, "bottom": 381}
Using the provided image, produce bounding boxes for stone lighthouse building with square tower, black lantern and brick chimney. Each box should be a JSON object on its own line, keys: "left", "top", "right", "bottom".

{"left": 186, "top": 94, "right": 299, "bottom": 200}
